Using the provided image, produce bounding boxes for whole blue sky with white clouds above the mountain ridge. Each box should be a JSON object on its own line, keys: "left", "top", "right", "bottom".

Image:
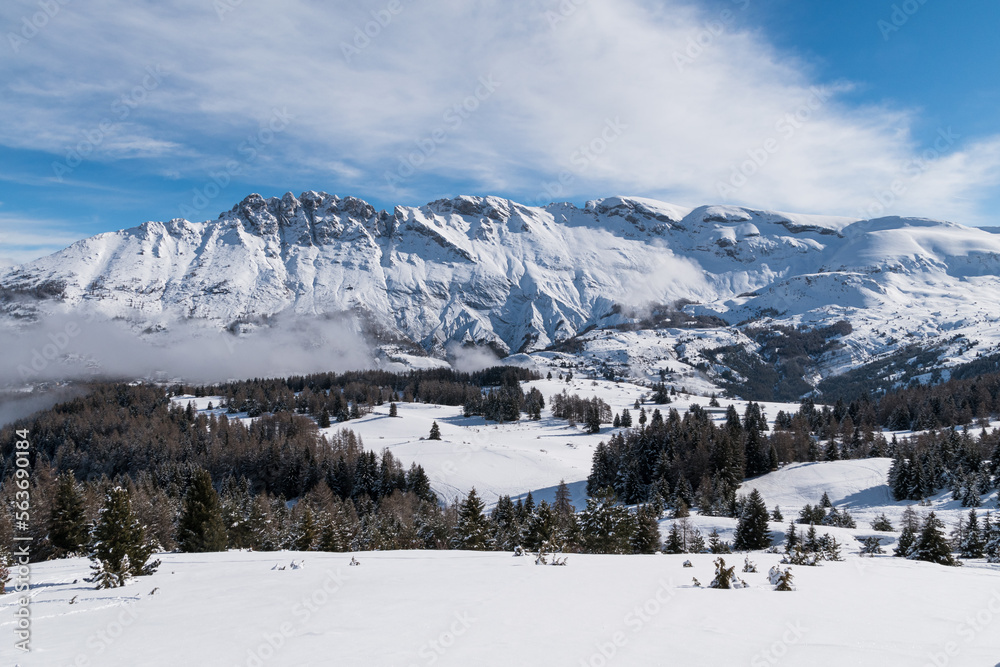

{"left": 0, "top": 0, "right": 1000, "bottom": 263}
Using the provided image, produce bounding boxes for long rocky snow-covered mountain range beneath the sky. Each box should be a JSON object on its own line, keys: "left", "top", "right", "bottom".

{"left": 0, "top": 192, "right": 1000, "bottom": 392}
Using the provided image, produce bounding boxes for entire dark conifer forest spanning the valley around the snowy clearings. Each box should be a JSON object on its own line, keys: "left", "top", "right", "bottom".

{"left": 0, "top": 354, "right": 1000, "bottom": 586}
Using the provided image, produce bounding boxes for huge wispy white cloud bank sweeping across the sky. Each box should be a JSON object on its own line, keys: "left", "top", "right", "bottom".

{"left": 0, "top": 0, "right": 1000, "bottom": 223}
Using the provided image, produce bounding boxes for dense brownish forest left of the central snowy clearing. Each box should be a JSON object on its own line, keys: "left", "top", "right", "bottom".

{"left": 0, "top": 384, "right": 441, "bottom": 559}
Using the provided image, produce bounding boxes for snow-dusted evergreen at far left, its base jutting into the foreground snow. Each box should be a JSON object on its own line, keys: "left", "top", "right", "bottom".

{"left": 90, "top": 487, "right": 160, "bottom": 588}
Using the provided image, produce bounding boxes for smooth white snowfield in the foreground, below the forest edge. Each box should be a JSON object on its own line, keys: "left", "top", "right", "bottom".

{"left": 0, "top": 551, "right": 1000, "bottom": 667}
